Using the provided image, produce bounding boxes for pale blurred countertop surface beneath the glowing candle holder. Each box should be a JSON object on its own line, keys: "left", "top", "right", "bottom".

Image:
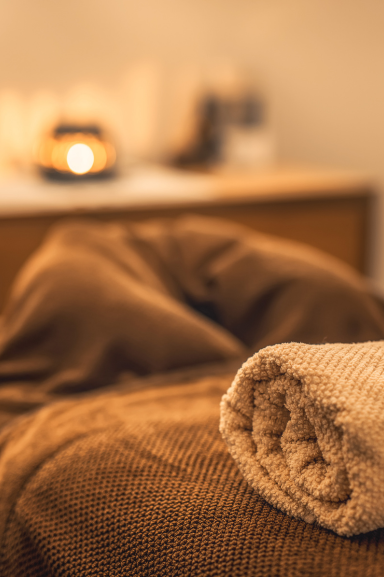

{"left": 0, "top": 165, "right": 373, "bottom": 217}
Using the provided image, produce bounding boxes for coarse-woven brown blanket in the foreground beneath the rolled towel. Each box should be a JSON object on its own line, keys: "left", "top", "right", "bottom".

{"left": 0, "top": 374, "right": 384, "bottom": 577}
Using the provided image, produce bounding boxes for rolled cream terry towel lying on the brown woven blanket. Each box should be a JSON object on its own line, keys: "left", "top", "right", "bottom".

{"left": 220, "top": 341, "right": 384, "bottom": 536}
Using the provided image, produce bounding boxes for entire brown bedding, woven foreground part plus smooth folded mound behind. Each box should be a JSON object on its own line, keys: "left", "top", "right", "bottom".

{"left": 0, "top": 217, "right": 384, "bottom": 576}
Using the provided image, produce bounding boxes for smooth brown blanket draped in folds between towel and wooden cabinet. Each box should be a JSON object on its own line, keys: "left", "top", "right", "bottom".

{"left": 0, "top": 216, "right": 384, "bottom": 426}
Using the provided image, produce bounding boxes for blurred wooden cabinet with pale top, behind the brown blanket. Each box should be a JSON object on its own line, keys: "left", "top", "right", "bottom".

{"left": 0, "top": 166, "right": 375, "bottom": 310}
